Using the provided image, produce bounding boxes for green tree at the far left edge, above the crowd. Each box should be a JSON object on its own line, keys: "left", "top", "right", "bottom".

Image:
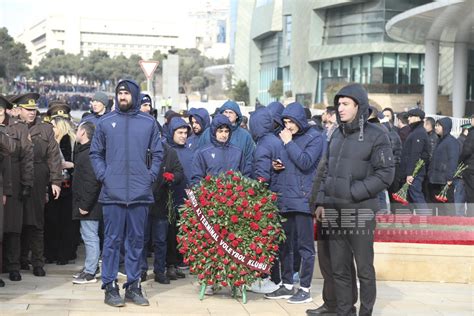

{"left": 0, "top": 27, "right": 31, "bottom": 91}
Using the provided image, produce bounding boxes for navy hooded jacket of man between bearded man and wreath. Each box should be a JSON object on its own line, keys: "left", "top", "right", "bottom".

{"left": 168, "top": 117, "right": 193, "bottom": 205}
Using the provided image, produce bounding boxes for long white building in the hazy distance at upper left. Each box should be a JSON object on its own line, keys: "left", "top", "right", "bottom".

{"left": 16, "top": 0, "right": 230, "bottom": 66}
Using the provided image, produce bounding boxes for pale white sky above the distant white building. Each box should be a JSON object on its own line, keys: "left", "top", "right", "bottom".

{"left": 0, "top": 0, "right": 229, "bottom": 37}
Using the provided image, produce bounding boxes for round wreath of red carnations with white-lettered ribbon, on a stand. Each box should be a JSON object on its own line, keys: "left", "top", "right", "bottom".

{"left": 177, "top": 171, "right": 285, "bottom": 303}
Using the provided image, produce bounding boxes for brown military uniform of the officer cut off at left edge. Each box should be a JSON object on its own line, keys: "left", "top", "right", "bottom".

{"left": 0, "top": 96, "right": 33, "bottom": 281}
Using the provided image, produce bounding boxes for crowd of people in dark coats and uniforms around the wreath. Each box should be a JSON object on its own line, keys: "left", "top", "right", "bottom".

{"left": 0, "top": 80, "right": 474, "bottom": 315}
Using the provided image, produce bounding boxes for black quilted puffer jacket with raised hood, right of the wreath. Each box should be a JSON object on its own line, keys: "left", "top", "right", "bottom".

{"left": 316, "top": 84, "right": 395, "bottom": 211}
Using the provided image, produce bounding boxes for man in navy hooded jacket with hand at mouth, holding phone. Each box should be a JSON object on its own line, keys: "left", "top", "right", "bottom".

{"left": 265, "top": 102, "right": 324, "bottom": 304}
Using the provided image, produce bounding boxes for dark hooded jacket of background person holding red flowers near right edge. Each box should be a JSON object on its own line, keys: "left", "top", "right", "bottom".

{"left": 428, "top": 117, "right": 461, "bottom": 184}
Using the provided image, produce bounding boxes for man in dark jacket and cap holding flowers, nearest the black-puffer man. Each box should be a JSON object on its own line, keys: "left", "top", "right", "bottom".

{"left": 400, "top": 108, "right": 431, "bottom": 214}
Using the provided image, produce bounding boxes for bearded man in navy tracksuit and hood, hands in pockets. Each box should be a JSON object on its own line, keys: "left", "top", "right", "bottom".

{"left": 90, "top": 80, "right": 163, "bottom": 307}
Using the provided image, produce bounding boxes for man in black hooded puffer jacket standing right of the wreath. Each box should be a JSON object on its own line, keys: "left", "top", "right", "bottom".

{"left": 316, "top": 84, "right": 395, "bottom": 315}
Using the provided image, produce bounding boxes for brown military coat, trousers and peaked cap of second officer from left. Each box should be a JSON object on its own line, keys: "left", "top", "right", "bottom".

{"left": 11, "top": 93, "right": 62, "bottom": 276}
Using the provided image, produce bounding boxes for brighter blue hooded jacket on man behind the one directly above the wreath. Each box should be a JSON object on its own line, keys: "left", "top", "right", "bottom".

{"left": 198, "top": 100, "right": 255, "bottom": 164}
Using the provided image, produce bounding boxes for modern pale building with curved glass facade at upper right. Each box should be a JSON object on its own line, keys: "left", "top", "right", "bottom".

{"left": 235, "top": 0, "right": 472, "bottom": 114}
